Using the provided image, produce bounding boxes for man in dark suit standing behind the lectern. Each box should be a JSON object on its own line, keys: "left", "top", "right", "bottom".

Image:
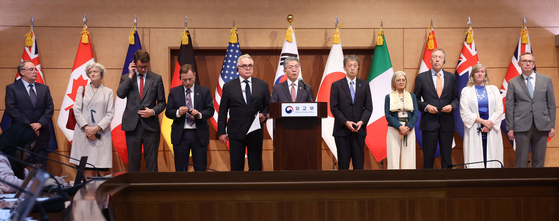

{"left": 270, "top": 57, "right": 313, "bottom": 102}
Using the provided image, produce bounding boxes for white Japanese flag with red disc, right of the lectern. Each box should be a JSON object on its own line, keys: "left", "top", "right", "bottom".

{"left": 316, "top": 28, "right": 346, "bottom": 159}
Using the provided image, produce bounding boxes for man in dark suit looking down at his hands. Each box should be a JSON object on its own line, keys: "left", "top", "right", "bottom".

{"left": 165, "top": 64, "right": 214, "bottom": 172}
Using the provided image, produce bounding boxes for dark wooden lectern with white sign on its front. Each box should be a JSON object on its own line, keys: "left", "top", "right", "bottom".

{"left": 269, "top": 102, "right": 328, "bottom": 171}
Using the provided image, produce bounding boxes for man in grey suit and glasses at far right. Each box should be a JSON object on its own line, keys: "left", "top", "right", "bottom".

{"left": 505, "top": 52, "right": 556, "bottom": 167}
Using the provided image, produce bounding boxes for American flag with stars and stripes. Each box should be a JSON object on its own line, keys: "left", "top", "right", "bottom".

{"left": 211, "top": 35, "right": 241, "bottom": 142}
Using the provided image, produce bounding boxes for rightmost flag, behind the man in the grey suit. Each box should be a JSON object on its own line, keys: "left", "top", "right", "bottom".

{"left": 501, "top": 26, "right": 536, "bottom": 146}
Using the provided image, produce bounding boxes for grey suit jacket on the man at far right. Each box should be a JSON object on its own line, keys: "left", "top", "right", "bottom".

{"left": 505, "top": 73, "right": 555, "bottom": 132}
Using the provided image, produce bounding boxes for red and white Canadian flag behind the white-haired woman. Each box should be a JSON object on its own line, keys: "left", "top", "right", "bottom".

{"left": 58, "top": 25, "right": 95, "bottom": 142}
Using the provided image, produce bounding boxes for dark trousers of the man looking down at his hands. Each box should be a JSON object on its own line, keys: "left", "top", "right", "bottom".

{"left": 173, "top": 129, "right": 208, "bottom": 172}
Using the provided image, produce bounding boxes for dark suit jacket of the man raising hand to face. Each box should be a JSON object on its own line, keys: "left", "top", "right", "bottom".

{"left": 116, "top": 70, "right": 166, "bottom": 131}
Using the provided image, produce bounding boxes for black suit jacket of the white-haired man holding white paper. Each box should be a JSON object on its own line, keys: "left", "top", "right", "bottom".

{"left": 217, "top": 77, "right": 270, "bottom": 140}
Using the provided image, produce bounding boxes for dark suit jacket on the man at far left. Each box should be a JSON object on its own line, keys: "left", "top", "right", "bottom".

{"left": 5, "top": 79, "right": 54, "bottom": 140}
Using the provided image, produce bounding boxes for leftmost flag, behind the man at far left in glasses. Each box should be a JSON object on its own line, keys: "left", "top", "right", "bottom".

{"left": 0, "top": 28, "right": 58, "bottom": 151}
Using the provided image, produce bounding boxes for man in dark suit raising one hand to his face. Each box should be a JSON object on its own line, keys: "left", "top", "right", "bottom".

{"left": 117, "top": 50, "right": 166, "bottom": 172}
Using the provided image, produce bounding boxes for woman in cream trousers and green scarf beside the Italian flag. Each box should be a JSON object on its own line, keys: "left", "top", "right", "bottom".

{"left": 384, "top": 71, "right": 418, "bottom": 169}
